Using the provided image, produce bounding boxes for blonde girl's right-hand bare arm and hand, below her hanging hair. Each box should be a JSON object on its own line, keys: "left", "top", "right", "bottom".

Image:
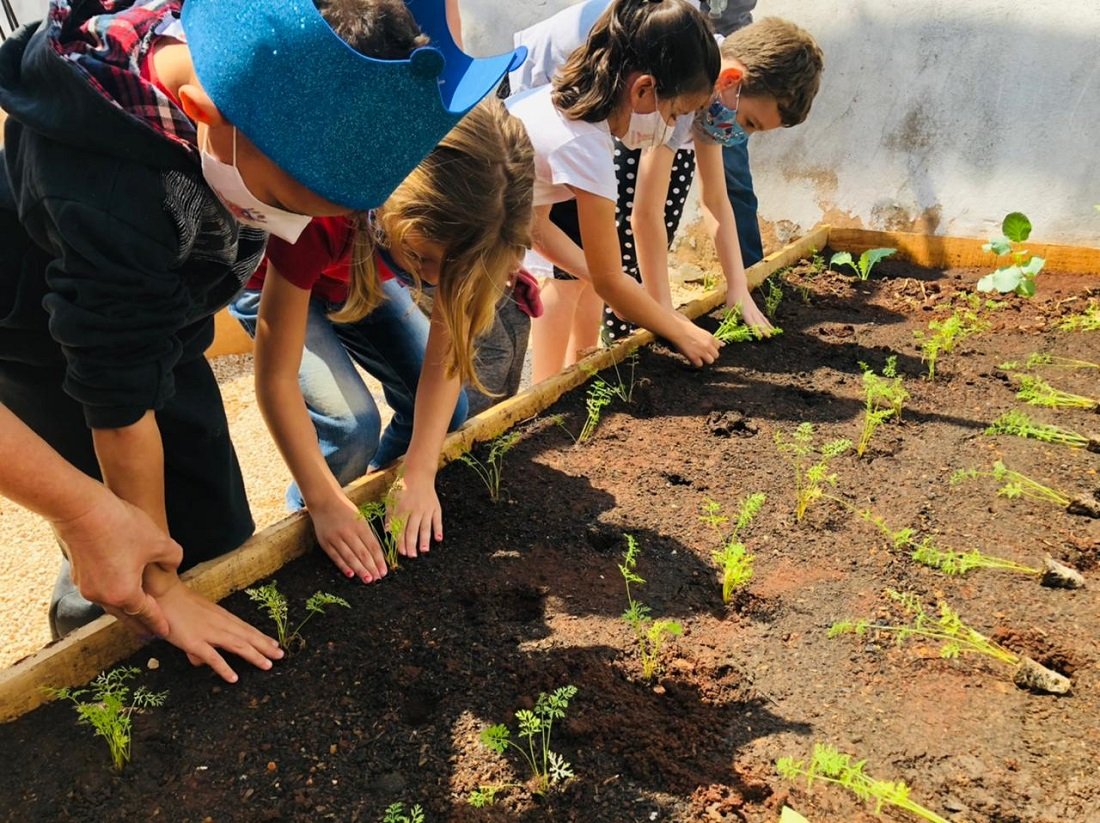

{"left": 388, "top": 299, "right": 462, "bottom": 557}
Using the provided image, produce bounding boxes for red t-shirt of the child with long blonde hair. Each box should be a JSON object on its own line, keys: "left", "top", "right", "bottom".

{"left": 245, "top": 217, "right": 394, "bottom": 304}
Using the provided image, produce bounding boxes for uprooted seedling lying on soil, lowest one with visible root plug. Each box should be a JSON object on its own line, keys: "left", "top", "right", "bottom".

{"left": 828, "top": 590, "right": 1071, "bottom": 694}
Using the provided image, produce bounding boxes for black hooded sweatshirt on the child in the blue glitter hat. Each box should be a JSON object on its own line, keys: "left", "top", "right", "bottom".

{"left": 0, "top": 0, "right": 266, "bottom": 428}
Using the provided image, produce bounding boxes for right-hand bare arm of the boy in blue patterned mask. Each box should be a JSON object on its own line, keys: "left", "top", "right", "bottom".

{"left": 695, "top": 140, "right": 772, "bottom": 334}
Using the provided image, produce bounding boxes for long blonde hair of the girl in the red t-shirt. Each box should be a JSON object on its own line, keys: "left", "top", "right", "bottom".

{"left": 329, "top": 98, "right": 535, "bottom": 391}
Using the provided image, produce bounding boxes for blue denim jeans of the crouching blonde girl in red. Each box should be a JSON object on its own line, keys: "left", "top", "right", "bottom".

{"left": 229, "top": 281, "right": 466, "bottom": 509}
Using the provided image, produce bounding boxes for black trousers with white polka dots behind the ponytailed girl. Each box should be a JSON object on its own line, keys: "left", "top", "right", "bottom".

{"left": 602, "top": 140, "right": 695, "bottom": 343}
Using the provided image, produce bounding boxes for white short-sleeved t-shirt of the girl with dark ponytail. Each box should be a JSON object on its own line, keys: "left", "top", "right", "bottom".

{"left": 506, "top": 86, "right": 618, "bottom": 206}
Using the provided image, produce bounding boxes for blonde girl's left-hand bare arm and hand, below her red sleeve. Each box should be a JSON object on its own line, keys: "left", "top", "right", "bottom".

{"left": 255, "top": 265, "right": 386, "bottom": 583}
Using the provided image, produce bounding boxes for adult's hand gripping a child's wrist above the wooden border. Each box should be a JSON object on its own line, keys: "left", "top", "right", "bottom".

{"left": 52, "top": 484, "right": 184, "bottom": 637}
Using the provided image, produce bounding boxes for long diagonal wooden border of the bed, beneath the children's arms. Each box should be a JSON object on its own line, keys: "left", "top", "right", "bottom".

{"left": 0, "top": 227, "right": 829, "bottom": 723}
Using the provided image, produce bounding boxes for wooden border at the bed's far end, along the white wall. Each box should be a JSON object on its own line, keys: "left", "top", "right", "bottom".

{"left": 828, "top": 229, "right": 1100, "bottom": 277}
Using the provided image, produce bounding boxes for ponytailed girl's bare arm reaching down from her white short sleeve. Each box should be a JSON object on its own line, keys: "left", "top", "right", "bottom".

{"left": 576, "top": 189, "right": 721, "bottom": 365}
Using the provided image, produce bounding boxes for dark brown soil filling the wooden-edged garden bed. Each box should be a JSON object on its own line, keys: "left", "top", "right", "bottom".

{"left": 0, "top": 261, "right": 1100, "bottom": 823}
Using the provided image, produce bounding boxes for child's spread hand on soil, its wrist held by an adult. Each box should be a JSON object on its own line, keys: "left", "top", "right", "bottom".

{"left": 144, "top": 566, "right": 283, "bottom": 683}
